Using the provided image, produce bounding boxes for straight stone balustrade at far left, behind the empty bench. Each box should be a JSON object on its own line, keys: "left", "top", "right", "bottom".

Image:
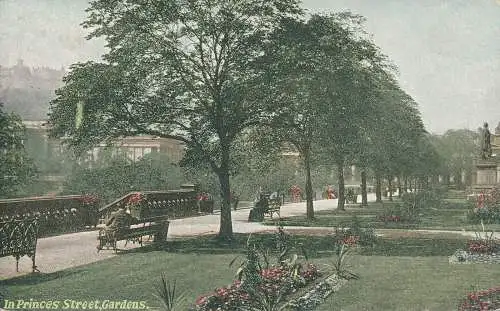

{"left": 0, "top": 195, "right": 99, "bottom": 236}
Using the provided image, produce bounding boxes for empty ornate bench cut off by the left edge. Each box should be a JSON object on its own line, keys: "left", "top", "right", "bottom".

{"left": 0, "top": 218, "right": 39, "bottom": 272}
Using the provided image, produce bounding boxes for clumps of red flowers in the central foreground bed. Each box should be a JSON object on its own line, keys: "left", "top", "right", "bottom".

{"left": 192, "top": 264, "right": 321, "bottom": 311}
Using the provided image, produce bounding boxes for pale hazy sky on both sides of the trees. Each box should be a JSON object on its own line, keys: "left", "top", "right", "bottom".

{"left": 0, "top": 0, "right": 500, "bottom": 134}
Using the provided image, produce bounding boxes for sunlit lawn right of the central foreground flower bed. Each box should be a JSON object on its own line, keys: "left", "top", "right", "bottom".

{"left": 318, "top": 256, "right": 500, "bottom": 311}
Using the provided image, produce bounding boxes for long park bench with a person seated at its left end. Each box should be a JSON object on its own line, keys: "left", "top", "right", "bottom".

{"left": 97, "top": 216, "right": 170, "bottom": 253}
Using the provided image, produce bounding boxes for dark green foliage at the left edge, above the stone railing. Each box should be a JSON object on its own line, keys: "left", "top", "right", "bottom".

{"left": 0, "top": 103, "right": 37, "bottom": 198}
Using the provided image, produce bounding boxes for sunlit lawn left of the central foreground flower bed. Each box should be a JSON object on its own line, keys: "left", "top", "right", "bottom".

{"left": 0, "top": 251, "right": 240, "bottom": 307}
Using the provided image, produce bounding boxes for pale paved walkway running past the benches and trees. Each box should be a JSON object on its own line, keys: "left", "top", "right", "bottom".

{"left": 0, "top": 195, "right": 496, "bottom": 279}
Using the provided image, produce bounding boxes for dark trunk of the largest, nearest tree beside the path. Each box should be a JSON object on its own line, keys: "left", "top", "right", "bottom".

{"left": 217, "top": 147, "right": 233, "bottom": 240}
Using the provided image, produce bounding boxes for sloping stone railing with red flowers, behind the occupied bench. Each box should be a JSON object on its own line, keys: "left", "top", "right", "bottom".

{"left": 99, "top": 189, "right": 202, "bottom": 223}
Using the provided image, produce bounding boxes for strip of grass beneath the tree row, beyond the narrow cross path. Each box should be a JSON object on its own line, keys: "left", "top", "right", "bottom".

{"left": 264, "top": 201, "right": 500, "bottom": 231}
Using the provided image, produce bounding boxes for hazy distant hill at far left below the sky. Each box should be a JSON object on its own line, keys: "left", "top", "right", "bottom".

{"left": 0, "top": 60, "right": 65, "bottom": 121}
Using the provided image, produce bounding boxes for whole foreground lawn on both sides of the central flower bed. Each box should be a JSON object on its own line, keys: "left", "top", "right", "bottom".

{"left": 0, "top": 234, "right": 500, "bottom": 311}
